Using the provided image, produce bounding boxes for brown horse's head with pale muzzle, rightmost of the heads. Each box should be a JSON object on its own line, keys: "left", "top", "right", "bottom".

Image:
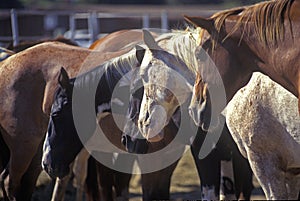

{"left": 186, "top": 17, "right": 247, "bottom": 131}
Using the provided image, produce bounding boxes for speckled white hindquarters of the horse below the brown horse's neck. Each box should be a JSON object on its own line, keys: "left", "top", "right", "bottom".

{"left": 226, "top": 72, "right": 300, "bottom": 200}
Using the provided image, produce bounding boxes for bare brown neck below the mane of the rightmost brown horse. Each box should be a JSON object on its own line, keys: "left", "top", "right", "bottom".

{"left": 226, "top": 17, "right": 300, "bottom": 96}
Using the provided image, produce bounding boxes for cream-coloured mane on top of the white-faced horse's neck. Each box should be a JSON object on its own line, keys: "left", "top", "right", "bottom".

{"left": 156, "top": 27, "right": 200, "bottom": 74}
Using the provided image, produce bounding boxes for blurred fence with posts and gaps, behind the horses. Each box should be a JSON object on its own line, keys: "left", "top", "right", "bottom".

{"left": 0, "top": 6, "right": 216, "bottom": 45}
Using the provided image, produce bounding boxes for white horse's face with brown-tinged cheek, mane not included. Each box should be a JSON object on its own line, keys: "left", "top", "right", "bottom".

{"left": 138, "top": 31, "right": 193, "bottom": 142}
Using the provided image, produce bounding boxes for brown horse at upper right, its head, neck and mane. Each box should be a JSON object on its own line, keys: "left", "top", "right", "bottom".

{"left": 185, "top": 0, "right": 300, "bottom": 129}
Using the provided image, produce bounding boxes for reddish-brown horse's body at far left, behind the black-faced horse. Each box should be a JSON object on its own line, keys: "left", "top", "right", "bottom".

{"left": 0, "top": 31, "right": 152, "bottom": 200}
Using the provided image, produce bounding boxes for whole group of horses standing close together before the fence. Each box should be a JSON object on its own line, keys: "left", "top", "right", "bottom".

{"left": 0, "top": 0, "right": 300, "bottom": 201}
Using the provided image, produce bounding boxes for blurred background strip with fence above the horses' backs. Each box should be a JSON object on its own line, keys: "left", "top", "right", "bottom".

{"left": 0, "top": 0, "right": 259, "bottom": 47}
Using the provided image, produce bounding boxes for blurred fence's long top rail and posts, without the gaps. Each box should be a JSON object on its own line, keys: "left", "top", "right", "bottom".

{"left": 0, "top": 8, "right": 216, "bottom": 45}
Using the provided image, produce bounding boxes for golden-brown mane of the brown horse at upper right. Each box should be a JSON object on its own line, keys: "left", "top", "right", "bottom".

{"left": 211, "top": 0, "right": 294, "bottom": 45}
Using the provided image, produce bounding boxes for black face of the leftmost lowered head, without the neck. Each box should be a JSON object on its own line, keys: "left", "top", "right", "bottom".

{"left": 42, "top": 68, "right": 83, "bottom": 177}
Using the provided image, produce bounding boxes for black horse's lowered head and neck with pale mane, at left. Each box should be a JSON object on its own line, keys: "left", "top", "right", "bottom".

{"left": 42, "top": 47, "right": 148, "bottom": 177}
